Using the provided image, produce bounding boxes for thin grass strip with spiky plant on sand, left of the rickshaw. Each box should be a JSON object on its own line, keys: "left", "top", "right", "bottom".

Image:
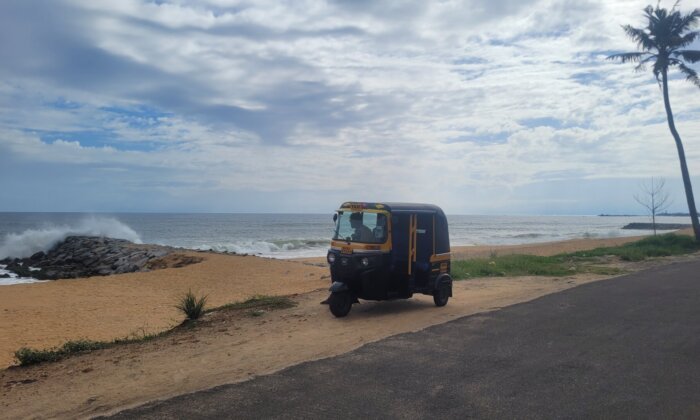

{"left": 15, "top": 292, "right": 297, "bottom": 366}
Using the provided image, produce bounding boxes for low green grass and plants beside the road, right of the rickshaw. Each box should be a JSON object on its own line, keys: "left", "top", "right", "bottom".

{"left": 451, "top": 233, "right": 700, "bottom": 280}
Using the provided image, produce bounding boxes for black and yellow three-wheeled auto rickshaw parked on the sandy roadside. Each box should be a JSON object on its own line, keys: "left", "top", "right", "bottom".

{"left": 327, "top": 202, "right": 452, "bottom": 317}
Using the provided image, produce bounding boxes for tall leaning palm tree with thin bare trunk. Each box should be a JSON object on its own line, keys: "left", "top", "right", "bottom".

{"left": 608, "top": 2, "right": 700, "bottom": 242}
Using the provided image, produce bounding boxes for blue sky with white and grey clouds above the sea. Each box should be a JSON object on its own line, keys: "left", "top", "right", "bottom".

{"left": 0, "top": 0, "right": 700, "bottom": 215}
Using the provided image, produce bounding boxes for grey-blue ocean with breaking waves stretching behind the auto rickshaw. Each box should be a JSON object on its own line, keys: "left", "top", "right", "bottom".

{"left": 0, "top": 213, "right": 690, "bottom": 285}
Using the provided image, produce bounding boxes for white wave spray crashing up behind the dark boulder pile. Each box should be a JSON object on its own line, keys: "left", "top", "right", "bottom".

{"left": 0, "top": 217, "right": 142, "bottom": 259}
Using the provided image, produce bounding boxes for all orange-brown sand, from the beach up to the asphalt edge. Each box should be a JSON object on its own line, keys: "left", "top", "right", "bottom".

{"left": 0, "top": 231, "right": 696, "bottom": 418}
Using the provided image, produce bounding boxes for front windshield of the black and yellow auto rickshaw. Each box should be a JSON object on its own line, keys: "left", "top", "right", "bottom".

{"left": 333, "top": 211, "right": 387, "bottom": 244}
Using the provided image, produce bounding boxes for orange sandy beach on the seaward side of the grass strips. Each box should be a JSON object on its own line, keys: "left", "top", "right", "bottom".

{"left": 0, "top": 233, "right": 656, "bottom": 366}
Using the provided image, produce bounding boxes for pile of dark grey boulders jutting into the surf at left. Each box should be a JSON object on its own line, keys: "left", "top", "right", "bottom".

{"left": 0, "top": 236, "right": 202, "bottom": 280}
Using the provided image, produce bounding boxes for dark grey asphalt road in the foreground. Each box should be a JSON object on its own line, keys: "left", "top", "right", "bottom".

{"left": 110, "top": 261, "right": 700, "bottom": 419}
